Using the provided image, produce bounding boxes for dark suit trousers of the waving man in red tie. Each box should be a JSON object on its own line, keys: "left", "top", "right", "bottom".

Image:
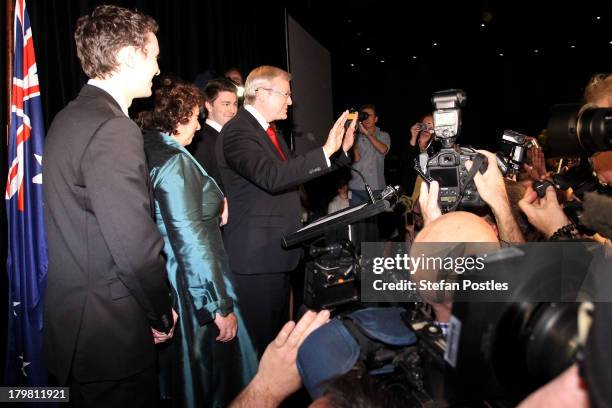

{"left": 232, "top": 272, "right": 289, "bottom": 358}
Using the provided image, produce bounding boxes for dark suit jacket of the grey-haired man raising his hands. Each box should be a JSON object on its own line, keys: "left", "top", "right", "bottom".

{"left": 216, "top": 108, "right": 348, "bottom": 274}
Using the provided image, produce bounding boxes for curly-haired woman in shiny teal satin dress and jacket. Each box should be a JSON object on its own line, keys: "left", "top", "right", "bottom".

{"left": 137, "top": 79, "right": 257, "bottom": 407}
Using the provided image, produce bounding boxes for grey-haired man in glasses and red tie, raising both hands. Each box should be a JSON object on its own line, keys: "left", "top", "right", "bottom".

{"left": 217, "top": 66, "right": 355, "bottom": 353}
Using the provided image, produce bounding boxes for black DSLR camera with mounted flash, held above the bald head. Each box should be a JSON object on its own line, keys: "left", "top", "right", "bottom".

{"left": 415, "top": 89, "right": 487, "bottom": 212}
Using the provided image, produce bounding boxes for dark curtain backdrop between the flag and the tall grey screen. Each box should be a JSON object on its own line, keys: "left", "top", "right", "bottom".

{"left": 27, "top": 0, "right": 287, "bottom": 127}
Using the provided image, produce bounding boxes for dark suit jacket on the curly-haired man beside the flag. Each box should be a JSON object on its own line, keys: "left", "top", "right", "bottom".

{"left": 43, "top": 85, "right": 172, "bottom": 383}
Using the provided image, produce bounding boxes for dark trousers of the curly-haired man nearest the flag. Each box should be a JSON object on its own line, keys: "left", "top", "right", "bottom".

{"left": 70, "top": 364, "right": 159, "bottom": 408}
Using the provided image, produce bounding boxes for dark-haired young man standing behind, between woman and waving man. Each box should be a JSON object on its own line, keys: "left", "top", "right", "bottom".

{"left": 189, "top": 78, "right": 238, "bottom": 190}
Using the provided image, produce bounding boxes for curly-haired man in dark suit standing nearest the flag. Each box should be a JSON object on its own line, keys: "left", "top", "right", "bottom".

{"left": 43, "top": 6, "right": 176, "bottom": 407}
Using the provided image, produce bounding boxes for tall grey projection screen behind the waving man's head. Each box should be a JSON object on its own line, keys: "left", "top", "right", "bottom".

{"left": 286, "top": 14, "right": 334, "bottom": 154}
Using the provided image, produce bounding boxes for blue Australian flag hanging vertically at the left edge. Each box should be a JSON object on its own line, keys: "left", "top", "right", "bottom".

{"left": 5, "top": 0, "right": 47, "bottom": 386}
